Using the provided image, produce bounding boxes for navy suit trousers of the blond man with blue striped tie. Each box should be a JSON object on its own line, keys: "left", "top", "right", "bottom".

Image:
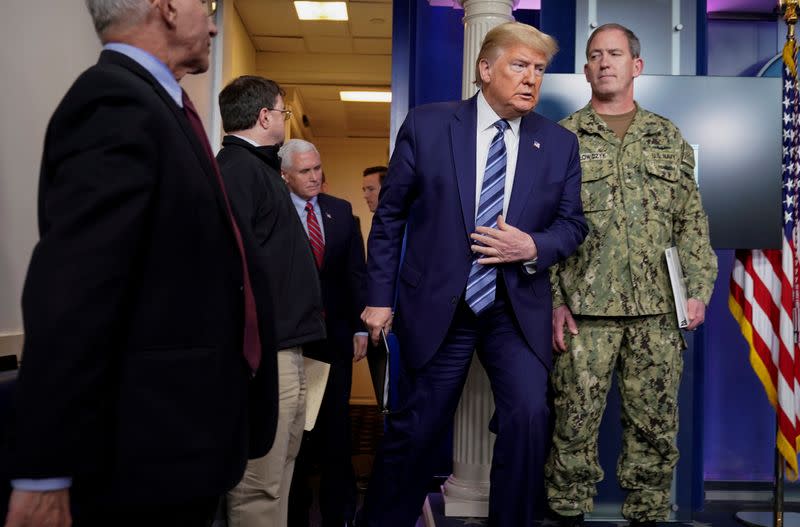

{"left": 357, "top": 284, "right": 551, "bottom": 527}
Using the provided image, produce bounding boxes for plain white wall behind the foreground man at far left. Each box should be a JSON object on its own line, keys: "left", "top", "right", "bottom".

{"left": 0, "top": 0, "right": 219, "bottom": 355}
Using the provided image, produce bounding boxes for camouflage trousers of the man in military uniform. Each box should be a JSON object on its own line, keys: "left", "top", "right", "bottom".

{"left": 545, "top": 314, "right": 684, "bottom": 521}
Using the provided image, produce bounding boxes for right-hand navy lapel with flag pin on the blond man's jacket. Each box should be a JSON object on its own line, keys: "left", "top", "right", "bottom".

{"left": 506, "top": 113, "right": 544, "bottom": 225}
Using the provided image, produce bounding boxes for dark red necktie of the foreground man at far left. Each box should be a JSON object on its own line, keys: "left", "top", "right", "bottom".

{"left": 183, "top": 92, "right": 261, "bottom": 373}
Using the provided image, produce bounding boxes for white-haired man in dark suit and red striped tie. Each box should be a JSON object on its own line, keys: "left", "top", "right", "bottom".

{"left": 279, "top": 139, "right": 367, "bottom": 527}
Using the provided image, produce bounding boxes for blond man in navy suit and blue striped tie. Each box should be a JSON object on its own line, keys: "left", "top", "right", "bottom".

{"left": 358, "top": 22, "right": 587, "bottom": 527}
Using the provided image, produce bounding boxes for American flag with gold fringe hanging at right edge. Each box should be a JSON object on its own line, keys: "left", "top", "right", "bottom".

{"left": 728, "top": 38, "right": 800, "bottom": 481}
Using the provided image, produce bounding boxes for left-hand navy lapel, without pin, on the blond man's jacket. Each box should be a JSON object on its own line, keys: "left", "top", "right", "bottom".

{"left": 450, "top": 96, "right": 478, "bottom": 236}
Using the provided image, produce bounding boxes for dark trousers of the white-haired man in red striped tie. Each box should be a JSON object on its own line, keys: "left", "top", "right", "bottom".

{"left": 289, "top": 357, "right": 356, "bottom": 527}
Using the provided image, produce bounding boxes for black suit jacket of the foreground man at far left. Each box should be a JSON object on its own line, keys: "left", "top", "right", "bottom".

{"left": 5, "top": 51, "right": 277, "bottom": 504}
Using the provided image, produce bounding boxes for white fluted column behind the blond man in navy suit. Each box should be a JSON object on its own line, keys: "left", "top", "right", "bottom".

{"left": 442, "top": 0, "right": 519, "bottom": 517}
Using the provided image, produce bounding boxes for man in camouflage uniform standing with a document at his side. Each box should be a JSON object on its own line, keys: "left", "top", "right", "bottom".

{"left": 545, "top": 24, "right": 717, "bottom": 526}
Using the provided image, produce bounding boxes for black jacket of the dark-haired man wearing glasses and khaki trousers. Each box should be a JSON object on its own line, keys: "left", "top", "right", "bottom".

{"left": 217, "top": 135, "right": 330, "bottom": 360}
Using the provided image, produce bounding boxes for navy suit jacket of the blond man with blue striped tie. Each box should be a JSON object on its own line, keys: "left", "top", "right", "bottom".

{"left": 367, "top": 97, "right": 587, "bottom": 368}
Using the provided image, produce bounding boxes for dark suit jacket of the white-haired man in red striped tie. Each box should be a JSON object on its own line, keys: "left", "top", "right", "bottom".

{"left": 317, "top": 194, "right": 366, "bottom": 359}
